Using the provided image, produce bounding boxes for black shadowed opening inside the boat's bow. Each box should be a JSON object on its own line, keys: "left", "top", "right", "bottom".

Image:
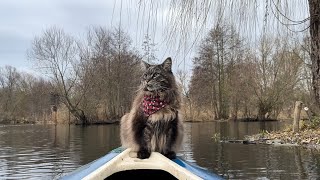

{"left": 105, "top": 169, "right": 177, "bottom": 180}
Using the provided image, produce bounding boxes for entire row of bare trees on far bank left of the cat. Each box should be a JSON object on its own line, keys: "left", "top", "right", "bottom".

{"left": 0, "top": 27, "right": 141, "bottom": 124}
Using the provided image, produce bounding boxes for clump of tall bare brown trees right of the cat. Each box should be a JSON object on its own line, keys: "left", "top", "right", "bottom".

{"left": 188, "top": 25, "right": 314, "bottom": 120}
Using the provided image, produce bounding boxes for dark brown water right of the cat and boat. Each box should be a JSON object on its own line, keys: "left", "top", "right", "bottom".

{"left": 182, "top": 122, "right": 320, "bottom": 179}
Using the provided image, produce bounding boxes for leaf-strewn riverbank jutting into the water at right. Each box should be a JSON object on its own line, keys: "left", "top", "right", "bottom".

{"left": 245, "top": 117, "right": 320, "bottom": 150}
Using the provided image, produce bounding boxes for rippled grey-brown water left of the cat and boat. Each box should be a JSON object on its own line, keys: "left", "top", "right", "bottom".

{"left": 0, "top": 125, "right": 120, "bottom": 179}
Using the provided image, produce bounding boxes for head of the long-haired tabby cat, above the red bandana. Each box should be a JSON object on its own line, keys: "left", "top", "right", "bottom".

{"left": 141, "top": 57, "right": 175, "bottom": 93}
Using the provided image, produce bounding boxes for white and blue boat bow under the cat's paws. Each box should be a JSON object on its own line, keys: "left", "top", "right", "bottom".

{"left": 62, "top": 147, "right": 221, "bottom": 179}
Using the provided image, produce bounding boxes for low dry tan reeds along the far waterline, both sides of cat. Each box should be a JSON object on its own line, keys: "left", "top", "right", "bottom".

{"left": 0, "top": 100, "right": 316, "bottom": 125}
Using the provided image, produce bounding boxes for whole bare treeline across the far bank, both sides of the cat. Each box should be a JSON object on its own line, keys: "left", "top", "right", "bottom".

{"left": 0, "top": 25, "right": 313, "bottom": 124}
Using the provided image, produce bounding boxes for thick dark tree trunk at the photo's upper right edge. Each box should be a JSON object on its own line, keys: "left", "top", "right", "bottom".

{"left": 309, "top": 0, "right": 320, "bottom": 110}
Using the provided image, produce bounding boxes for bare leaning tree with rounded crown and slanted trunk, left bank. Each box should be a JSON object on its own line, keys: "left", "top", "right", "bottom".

{"left": 28, "top": 27, "right": 87, "bottom": 124}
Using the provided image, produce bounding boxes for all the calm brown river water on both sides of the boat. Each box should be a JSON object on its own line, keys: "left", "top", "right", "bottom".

{"left": 0, "top": 122, "right": 320, "bottom": 179}
